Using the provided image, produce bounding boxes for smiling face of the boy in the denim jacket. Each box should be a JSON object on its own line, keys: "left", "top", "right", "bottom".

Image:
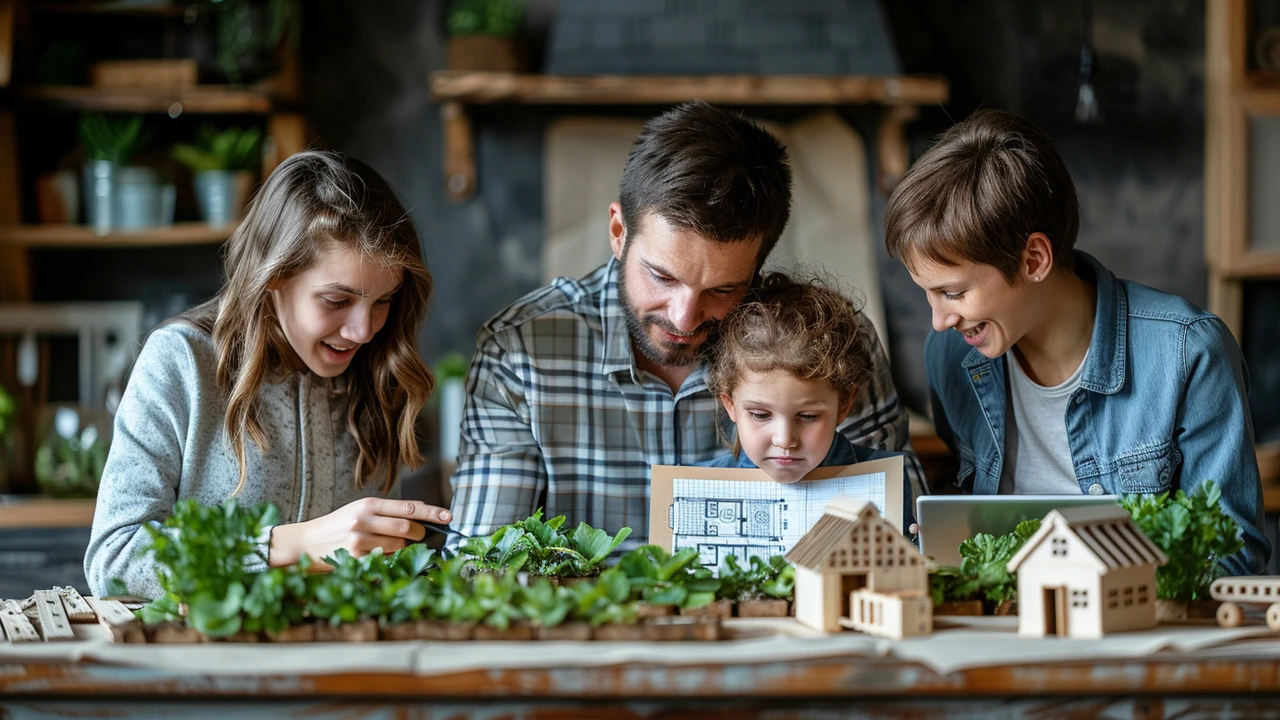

{"left": 911, "top": 260, "right": 1034, "bottom": 359}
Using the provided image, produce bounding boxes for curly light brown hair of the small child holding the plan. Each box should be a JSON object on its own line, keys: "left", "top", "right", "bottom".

{"left": 708, "top": 273, "right": 872, "bottom": 404}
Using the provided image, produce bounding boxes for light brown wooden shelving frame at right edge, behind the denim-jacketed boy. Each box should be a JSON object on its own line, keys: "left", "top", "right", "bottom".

{"left": 1204, "top": 0, "right": 1280, "bottom": 481}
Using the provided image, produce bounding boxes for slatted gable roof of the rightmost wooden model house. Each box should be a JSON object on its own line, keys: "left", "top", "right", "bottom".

{"left": 1009, "top": 505, "right": 1169, "bottom": 574}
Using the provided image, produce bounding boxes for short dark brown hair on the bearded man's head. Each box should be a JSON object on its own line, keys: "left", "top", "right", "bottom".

{"left": 618, "top": 100, "right": 791, "bottom": 263}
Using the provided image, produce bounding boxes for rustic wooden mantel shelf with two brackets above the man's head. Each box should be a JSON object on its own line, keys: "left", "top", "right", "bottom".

{"left": 431, "top": 70, "right": 947, "bottom": 202}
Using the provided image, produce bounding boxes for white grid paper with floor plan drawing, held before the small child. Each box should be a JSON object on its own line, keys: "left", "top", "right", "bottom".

{"left": 667, "top": 473, "right": 886, "bottom": 570}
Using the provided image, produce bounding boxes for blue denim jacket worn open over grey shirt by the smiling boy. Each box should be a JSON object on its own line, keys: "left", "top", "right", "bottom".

{"left": 924, "top": 251, "right": 1271, "bottom": 575}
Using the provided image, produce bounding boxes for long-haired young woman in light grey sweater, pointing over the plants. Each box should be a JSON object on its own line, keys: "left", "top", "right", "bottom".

{"left": 84, "top": 151, "right": 451, "bottom": 597}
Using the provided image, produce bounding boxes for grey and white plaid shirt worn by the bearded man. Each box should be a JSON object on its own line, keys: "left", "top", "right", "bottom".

{"left": 452, "top": 260, "right": 924, "bottom": 548}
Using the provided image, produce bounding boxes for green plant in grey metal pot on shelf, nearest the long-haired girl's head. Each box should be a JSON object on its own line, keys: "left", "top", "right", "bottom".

{"left": 172, "top": 123, "right": 262, "bottom": 225}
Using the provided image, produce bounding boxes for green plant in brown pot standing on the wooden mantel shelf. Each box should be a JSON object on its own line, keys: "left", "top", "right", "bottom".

{"left": 445, "top": 0, "right": 529, "bottom": 72}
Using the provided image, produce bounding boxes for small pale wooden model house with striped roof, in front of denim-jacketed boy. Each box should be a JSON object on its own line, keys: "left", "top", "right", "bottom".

{"left": 1009, "top": 505, "right": 1169, "bottom": 638}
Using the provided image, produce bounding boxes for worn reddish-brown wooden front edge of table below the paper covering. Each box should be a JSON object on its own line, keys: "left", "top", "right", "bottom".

{"left": 0, "top": 641, "right": 1280, "bottom": 720}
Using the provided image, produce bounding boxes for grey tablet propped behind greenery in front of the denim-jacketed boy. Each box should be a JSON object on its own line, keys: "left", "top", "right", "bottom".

{"left": 915, "top": 495, "right": 1119, "bottom": 565}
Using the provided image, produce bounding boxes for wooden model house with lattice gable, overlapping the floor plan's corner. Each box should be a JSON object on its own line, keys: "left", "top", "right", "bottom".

{"left": 786, "top": 496, "right": 933, "bottom": 638}
